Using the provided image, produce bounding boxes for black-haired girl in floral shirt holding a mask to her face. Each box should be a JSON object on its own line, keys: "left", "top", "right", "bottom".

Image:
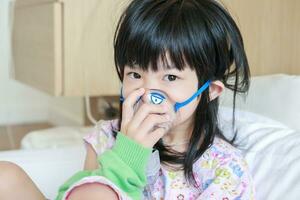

{"left": 0, "top": 0, "right": 254, "bottom": 200}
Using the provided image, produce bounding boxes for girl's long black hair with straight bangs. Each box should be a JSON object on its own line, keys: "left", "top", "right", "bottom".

{"left": 114, "top": 0, "right": 250, "bottom": 186}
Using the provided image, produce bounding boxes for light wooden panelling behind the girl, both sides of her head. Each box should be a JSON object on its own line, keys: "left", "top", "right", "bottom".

{"left": 12, "top": 0, "right": 300, "bottom": 96}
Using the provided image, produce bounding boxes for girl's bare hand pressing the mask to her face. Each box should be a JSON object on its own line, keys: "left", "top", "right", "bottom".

{"left": 121, "top": 88, "right": 171, "bottom": 147}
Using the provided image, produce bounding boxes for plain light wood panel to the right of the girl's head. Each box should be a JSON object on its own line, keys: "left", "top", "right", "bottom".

{"left": 219, "top": 0, "right": 300, "bottom": 75}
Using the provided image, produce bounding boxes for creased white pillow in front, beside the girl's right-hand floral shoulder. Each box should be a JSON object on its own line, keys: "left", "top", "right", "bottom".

{"left": 219, "top": 107, "right": 300, "bottom": 200}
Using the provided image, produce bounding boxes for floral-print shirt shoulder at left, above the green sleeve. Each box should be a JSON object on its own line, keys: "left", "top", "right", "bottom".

{"left": 83, "top": 119, "right": 118, "bottom": 155}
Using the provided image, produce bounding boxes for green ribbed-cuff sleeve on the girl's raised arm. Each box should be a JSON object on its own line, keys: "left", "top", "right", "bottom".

{"left": 56, "top": 132, "right": 152, "bottom": 200}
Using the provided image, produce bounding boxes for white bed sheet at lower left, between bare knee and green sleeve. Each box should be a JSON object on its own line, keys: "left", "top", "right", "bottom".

{"left": 0, "top": 146, "right": 85, "bottom": 200}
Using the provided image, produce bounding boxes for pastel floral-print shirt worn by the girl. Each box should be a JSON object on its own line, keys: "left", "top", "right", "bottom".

{"left": 84, "top": 120, "right": 254, "bottom": 200}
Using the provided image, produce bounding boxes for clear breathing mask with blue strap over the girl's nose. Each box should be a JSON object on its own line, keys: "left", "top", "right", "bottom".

{"left": 120, "top": 80, "right": 211, "bottom": 130}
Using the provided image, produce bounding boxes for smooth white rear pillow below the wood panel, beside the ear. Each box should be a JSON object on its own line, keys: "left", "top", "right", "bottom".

{"left": 220, "top": 74, "right": 300, "bottom": 130}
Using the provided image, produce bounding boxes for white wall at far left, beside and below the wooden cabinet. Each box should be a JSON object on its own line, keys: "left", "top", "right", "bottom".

{"left": 0, "top": 0, "right": 84, "bottom": 125}
